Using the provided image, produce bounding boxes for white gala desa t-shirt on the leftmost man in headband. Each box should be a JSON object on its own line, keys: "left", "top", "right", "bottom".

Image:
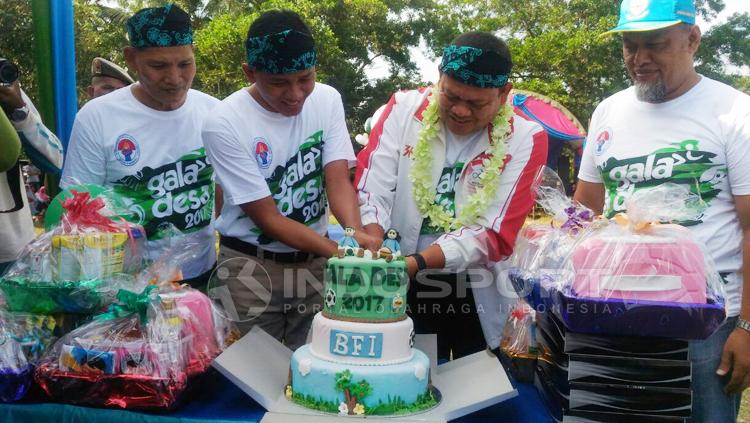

{"left": 61, "top": 88, "right": 219, "bottom": 279}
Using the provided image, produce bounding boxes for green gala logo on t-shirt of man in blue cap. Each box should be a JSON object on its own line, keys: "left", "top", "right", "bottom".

{"left": 599, "top": 140, "right": 727, "bottom": 226}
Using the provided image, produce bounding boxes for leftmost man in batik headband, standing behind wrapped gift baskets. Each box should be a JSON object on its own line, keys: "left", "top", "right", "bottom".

{"left": 61, "top": 5, "right": 218, "bottom": 285}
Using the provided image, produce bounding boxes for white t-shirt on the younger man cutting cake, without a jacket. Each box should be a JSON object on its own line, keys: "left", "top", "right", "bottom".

{"left": 203, "top": 83, "right": 354, "bottom": 252}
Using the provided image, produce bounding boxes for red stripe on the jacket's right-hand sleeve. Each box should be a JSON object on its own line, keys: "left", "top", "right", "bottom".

{"left": 486, "top": 131, "right": 547, "bottom": 261}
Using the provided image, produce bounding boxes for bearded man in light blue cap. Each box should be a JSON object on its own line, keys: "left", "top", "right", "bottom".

{"left": 575, "top": 0, "right": 750, "bottom": 422}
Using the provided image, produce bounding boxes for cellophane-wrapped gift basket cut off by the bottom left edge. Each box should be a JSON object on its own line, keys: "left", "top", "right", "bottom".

{"left": 0, "top": 311, "right": 55, "bottom": 402}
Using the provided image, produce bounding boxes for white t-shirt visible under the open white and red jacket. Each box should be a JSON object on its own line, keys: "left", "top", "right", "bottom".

{"left": 417, "top": 128, "right": 487, "bottom": 251}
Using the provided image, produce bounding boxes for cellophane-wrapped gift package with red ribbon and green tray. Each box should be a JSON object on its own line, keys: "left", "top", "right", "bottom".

{"left": 0, "top": 191, "right": 147, "bottom": 314}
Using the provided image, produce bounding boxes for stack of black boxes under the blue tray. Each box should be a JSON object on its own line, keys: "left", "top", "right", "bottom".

{"left": 534, "top": 312, "right": 692, "bottom": 423}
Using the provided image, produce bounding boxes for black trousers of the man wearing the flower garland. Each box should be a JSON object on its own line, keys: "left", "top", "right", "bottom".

{"left": 407, "top": 272, "right": 487, "bottom": 359}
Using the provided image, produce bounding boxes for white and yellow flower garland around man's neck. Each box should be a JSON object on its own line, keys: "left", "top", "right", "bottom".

{"left": 409, "top": 90, "right": 513, "bottom": 232}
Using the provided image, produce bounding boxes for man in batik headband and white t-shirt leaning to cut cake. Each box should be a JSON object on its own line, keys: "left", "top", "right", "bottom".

{"left": 203, "top": 11, "right": 382, "bottom": 348}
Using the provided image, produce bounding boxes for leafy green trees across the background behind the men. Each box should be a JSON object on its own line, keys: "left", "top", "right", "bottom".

{"left": 0, "top": 0, "right": 750, "bottom": 132}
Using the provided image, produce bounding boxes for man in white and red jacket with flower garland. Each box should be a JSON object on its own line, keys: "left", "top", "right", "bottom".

{"left": 356, "top": 32, "right": 547, "bottom": 358}
